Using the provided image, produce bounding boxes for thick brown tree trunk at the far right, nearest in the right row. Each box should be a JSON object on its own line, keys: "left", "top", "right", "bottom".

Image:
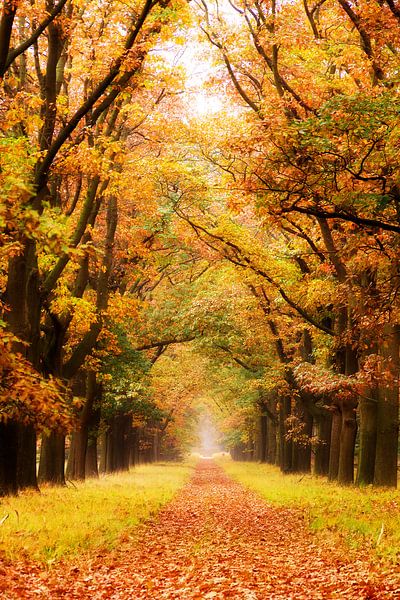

{"left": 374, "top": 324, "right": 400, "bottom": 487}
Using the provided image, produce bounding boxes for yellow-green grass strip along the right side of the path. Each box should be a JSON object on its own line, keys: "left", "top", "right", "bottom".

{"left": 218, "top": 459, "right": 400, "bottom": 561}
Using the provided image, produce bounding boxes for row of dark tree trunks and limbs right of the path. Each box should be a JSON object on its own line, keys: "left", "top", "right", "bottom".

{"left": 233, "top": 226, "right": 400, "bottom": 486}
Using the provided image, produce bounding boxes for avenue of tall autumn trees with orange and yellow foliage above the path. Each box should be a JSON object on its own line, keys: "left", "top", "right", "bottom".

{"left": 0, "top": 0, "right": 400, "bottom": 495}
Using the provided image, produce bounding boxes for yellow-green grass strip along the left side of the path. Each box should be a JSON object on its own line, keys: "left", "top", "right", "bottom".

{"left": 0, "top": 463, "right": 191, "bottom": 565}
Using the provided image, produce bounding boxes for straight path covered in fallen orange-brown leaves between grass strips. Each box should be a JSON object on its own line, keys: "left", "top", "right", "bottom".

{"left": 0, "top": 459, "right": 400, "bottom": 600}
